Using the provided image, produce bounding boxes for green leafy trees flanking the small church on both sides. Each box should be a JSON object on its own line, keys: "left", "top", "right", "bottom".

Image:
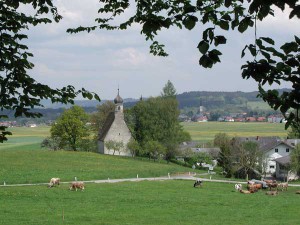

{"left": 43, "top": 81, "right": 190, "bottom": 160}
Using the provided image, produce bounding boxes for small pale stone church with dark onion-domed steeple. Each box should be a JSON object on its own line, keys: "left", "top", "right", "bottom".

{"left": 98, "top": 89, "right": 131, "bottom": 156}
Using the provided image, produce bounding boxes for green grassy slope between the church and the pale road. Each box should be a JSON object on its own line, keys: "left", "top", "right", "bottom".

{"left": 0, "top": 144, "right": 188, "bottom": 184}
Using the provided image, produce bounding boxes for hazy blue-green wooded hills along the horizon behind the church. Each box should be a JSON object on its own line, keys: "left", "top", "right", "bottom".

{"left": 2, "top": 89, "right": 289, "bottom": 122}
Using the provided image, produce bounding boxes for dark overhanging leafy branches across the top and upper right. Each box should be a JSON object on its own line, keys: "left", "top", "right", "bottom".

{"left": 68, "top": 0, "right": 300, "bottom": 128}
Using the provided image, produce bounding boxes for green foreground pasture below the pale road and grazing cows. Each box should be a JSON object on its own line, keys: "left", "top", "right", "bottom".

{"left": 0, "top": 180, "right": 300, "bottom": 225}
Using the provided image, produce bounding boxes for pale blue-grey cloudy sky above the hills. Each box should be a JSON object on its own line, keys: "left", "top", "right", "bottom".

{"left": 23, "top": 0, "right": 300, "bottom": 100}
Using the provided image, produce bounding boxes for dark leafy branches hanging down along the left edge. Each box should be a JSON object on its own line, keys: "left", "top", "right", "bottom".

{"left": 0, "top": 0, "right": 100, "bottom": 142}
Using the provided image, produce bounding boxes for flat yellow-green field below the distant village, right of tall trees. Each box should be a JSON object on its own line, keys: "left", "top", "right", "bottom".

{"left": 182, "top": 122, "right": 287, "bottom": 142}
